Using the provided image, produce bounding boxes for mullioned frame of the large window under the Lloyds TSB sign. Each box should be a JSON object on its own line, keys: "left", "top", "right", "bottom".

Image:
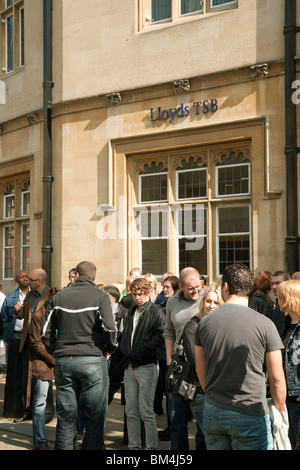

{"left": 133, "top": 143, "right": 252, "bottom": 277}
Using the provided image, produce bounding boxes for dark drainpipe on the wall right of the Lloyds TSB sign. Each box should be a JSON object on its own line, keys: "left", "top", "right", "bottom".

{"left": 284, "top": 0, "right": 300, "bottom": 273}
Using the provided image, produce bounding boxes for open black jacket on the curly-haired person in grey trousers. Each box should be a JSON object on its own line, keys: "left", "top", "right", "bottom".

{"left": 119, "top": 301, "right": 165, "bottom": 369}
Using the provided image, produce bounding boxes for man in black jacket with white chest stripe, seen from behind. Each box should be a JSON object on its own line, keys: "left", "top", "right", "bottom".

{"left": 43, "top": 261, "right": 116, "bottom": 450}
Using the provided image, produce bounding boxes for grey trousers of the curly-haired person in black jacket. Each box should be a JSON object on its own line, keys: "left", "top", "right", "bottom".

{"left": 124, "top": 364, "right": 158, "bottom": 450}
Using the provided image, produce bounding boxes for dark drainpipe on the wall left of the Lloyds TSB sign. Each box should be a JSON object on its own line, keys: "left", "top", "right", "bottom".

{"left": 42, "top": 0, "right": 53, "bottom": 286}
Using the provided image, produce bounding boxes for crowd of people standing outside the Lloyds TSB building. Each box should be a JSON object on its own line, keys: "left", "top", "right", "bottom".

{"left": 0, "top": 261, "right": 300, "bottom": 451}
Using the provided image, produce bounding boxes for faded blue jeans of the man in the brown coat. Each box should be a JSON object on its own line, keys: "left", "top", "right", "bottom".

{"left": 31, "top": 378, "right": 49, "bottom": 447}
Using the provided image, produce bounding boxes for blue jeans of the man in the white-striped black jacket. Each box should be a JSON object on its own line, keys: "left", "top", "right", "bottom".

{"left": 55, "top": 356, "right": 108, "bottom": 450}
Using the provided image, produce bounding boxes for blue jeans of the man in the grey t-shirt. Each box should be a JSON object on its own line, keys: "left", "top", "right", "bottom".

{"left": 203, "top": 403, "right": 273, "bottom": 450}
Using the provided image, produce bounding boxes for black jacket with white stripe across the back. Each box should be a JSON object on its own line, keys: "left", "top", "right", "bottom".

{"left": 44, "top": 278, "right": 116, "bottom": 358}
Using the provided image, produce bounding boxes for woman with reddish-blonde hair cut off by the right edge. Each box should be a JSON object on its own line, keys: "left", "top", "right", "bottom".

{"left": 277, "top": 279, "right": 300, "bottom": 450}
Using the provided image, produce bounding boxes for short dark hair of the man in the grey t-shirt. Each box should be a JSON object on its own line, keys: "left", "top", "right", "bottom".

{"left": 222, "top": 264, "right": 252, "bottom": 296}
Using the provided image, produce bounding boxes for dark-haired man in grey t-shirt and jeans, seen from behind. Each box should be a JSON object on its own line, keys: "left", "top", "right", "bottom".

{"left": 195, "top": 265, "right": 286, "bottom": 450}
